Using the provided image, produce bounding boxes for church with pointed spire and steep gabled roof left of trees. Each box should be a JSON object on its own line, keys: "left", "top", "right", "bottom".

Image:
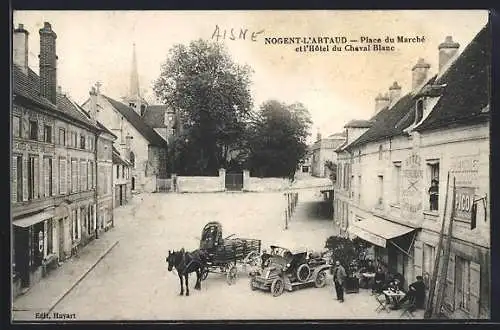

{"left": 82, "top": 45, "right": 170, "bottom": 192}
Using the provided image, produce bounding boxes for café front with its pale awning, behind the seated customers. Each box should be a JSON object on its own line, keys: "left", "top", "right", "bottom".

{"left": 349, "top": 217, "right": 418, "bottom": 289}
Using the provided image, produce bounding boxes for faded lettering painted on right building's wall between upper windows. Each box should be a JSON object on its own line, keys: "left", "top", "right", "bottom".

{"left": 401, "top": 153, "right": 423, "bottom": 219}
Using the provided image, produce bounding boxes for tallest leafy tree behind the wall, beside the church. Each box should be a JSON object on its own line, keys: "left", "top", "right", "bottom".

{"left": 153, "top": 39, "right": 252, "bottom": 175}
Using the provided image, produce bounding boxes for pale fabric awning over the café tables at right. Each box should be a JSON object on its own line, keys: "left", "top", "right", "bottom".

{"left": 349, "top": 218, "right": 416, "bottom": 247}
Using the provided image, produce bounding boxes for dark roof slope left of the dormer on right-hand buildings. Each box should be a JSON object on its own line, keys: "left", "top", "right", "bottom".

{"left": 347, "top": 94, "right": 415, "bottom": 149}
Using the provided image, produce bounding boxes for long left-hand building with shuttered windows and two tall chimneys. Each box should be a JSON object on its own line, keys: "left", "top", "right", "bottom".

{"left": 10, "top": 22, "right": 114, "bottom": 294}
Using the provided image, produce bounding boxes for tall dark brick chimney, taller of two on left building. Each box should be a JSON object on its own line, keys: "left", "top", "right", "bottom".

{"left": 39, "top": 22, "right": 57, "bottom": 104}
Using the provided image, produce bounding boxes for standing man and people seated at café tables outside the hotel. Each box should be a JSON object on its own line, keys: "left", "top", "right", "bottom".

{"left": 331, "top": 260, "right": 425, "bottom": 308}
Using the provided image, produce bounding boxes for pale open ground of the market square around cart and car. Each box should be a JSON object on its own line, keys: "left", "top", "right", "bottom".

{"left": 14, "top": 179, "right": 422, "bottom": 320}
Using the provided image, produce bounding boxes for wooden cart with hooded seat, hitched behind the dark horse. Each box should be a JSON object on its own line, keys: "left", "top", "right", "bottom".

{"left": 200, "top": 222, "right": 261, "bottom": 285}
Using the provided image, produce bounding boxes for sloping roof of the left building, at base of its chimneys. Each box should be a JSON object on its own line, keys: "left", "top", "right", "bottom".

{"left": 12, "top": 65, "right": 98, "bottom": 128}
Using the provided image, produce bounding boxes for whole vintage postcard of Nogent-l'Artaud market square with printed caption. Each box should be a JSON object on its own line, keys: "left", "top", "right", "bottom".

{"left": 10, "top": 10, "right": 492, "bottom": 322}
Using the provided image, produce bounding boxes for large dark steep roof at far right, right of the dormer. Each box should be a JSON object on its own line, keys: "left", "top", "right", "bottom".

{"left": 415, "top": 24, "right": 492, "bottom": 131}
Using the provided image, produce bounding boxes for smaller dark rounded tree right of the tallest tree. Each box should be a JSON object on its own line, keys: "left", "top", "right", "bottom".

{"left": 246, "top": 100, "right": 312, "bottom": 179}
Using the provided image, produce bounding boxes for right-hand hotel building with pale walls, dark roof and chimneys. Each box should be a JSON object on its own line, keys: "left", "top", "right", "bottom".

{"left": 334, "top": 26, "right": 491, "bottom": 319}
